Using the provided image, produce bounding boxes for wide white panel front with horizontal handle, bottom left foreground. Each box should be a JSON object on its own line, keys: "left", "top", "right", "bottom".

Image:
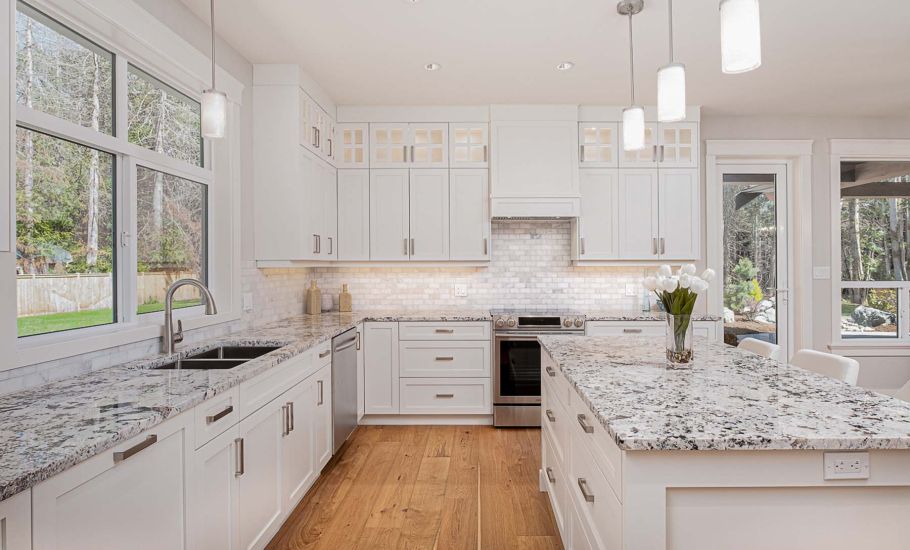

{"left": 32, "top": 414, "right": 193, "bottom": 550}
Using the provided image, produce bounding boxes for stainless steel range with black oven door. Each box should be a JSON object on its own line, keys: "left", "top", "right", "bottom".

{"left": 493, "top": 311, "right": 584, "bottom": 427}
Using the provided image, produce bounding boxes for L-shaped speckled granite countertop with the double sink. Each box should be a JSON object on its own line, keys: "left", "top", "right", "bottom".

{"left": 0, "top": 311, "right": 490, "bottom": 500}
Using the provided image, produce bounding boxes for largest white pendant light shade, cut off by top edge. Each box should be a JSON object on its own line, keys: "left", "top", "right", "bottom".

{"left": 720, "top": 0, "right": 761, "bottom": 74}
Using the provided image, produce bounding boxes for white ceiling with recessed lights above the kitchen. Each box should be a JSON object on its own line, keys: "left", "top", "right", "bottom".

{"left": 181, "top": 0, "right": 910, "bottom": 116}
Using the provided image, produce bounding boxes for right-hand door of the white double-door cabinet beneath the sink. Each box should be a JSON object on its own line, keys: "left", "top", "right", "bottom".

{"left": 278, "top": 376, "right": 319, "bottom": 510}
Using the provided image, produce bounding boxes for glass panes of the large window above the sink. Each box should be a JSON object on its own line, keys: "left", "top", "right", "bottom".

{"left": 15, "top": 2, "right": 212, "bottom": 338}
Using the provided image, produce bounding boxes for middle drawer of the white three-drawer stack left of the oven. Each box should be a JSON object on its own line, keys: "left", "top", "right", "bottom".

{"left": 398, "top": 340, "right": 490, "bottom": 378}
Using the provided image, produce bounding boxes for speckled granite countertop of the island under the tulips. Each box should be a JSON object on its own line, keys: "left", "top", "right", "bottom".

{"left": 539, "top": 336, "right": 910, "bottom": 451}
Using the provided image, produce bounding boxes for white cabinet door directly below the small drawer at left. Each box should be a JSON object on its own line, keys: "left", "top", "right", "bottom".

{"left": 186, "top": 425, "right": 240, "bottom": 550}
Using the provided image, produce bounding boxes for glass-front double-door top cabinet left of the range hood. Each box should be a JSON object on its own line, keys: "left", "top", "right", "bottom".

{"left": 369, "top": 122, "right": 449, "bottom": 168}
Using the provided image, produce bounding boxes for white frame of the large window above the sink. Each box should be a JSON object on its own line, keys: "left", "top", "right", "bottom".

{"left": 8, "top": 0, "right": 243, "bottom": 371}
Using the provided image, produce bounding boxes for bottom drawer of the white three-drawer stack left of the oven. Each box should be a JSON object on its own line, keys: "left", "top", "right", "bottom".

{"left": 399, "top": 378, "right": 491, "bottom": 414}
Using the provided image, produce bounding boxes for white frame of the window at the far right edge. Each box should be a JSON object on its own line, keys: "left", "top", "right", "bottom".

{"left": 829, "top": 139, "right": 910, "bottom": 355}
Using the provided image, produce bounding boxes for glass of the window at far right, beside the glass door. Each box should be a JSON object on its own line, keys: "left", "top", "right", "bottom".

{"left": 840, "top": 161, "right": 910, "bottom": 339}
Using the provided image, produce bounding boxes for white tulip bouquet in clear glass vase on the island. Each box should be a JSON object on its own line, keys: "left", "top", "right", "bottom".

{"left": 642, "top": 264, "right": 715, "bottom": 363}
